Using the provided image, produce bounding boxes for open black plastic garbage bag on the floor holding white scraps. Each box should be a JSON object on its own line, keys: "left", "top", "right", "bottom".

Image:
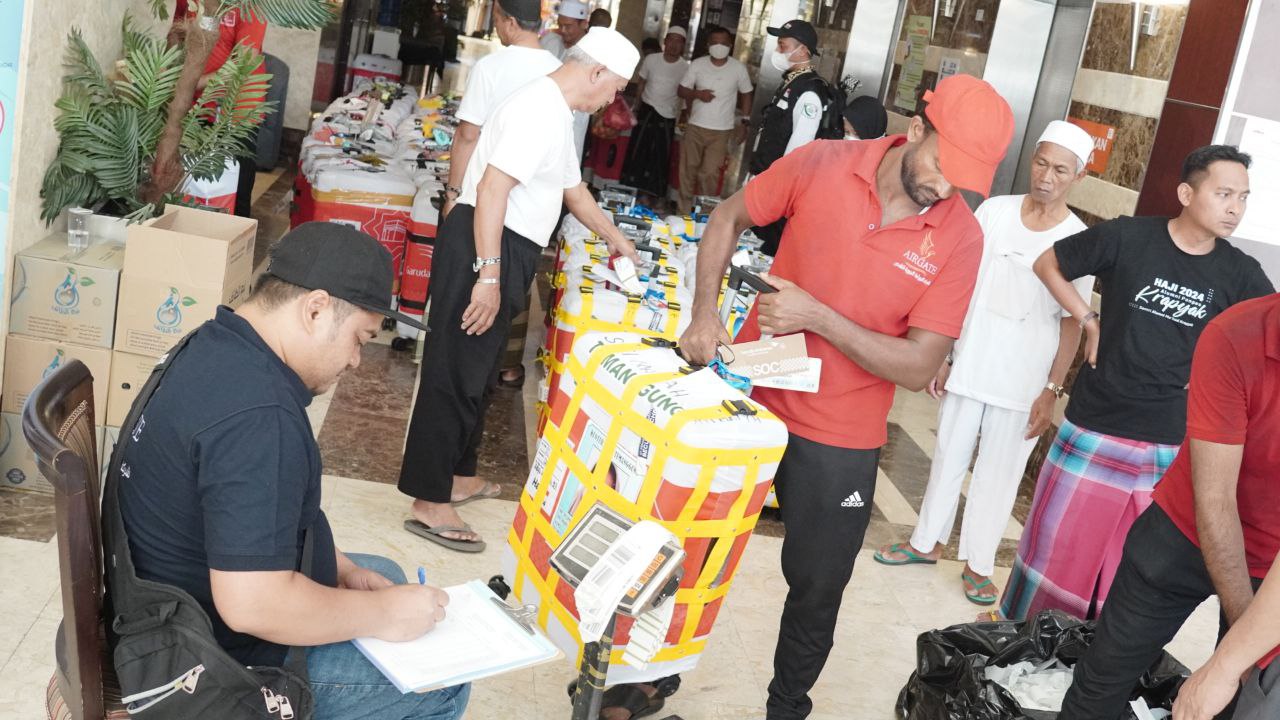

{"left": 897, "top": 610, "right": 1190, "bottom": 720}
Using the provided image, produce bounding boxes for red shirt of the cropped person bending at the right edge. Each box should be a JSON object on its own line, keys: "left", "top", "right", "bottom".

{"left": 1155, "top": 293, "right": 1280, "bottom": 578}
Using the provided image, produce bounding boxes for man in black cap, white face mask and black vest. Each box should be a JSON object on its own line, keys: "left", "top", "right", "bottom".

{"left": 749, "top": 20, "right": 844, "bottom": 255}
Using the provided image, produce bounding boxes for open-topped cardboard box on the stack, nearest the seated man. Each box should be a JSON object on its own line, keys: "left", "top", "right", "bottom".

{"left": 114, "top": 205, "right": 257, "bottom": 357}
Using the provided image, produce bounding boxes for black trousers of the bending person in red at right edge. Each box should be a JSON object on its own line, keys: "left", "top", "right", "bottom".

{"left": 1059, "top": 505, "right": 1262, "bottom": 720}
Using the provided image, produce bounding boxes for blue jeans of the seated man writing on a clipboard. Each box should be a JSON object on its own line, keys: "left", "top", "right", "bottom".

{"left": 307, "top": 555, "right": 471, "bottom": 720}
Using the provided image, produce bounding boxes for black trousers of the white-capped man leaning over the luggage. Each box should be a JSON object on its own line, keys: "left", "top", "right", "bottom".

{"left": 398, "top": 205, "right": 541, "bottom": 502}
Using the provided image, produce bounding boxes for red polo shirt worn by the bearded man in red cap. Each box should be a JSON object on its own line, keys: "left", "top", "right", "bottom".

{"left": 739, "top": 136, "right": 982, "bottom": 448}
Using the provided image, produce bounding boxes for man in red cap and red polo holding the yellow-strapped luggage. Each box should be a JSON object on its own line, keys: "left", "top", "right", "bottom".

{"left": 680, "top": 74, "right": 1014, "bottom": 720}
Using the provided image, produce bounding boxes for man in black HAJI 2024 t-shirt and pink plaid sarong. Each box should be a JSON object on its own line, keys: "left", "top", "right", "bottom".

{"left": 1001, "top": 145, "right": 1275, "bottom": 619}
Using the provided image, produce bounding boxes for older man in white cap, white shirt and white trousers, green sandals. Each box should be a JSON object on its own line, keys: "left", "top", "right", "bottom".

{"left": 876, "top": 120, "right": 1093, "bottom": 605}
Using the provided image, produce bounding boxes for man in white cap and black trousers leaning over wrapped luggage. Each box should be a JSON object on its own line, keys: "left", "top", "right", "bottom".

{"left": 399, "top": 27, "right": 640, "bottom": 552}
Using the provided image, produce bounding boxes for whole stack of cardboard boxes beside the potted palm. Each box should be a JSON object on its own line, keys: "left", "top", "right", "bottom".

{"left": 0, "top": 206, "right": 257, "bottom": 492}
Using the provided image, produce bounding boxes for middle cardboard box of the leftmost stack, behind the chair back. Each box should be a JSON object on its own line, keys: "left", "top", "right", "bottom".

{"left": 0, "top": 334, "right": 111, "bottom": 419}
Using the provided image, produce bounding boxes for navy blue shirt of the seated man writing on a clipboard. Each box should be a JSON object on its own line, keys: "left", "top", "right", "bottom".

{"left": 119, "top": 307, "right": 338, "bottom": 666}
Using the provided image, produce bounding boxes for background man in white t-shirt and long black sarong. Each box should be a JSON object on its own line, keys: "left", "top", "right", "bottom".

{"left": 622, "top": 26, "right": 689, "bottom": 202}
